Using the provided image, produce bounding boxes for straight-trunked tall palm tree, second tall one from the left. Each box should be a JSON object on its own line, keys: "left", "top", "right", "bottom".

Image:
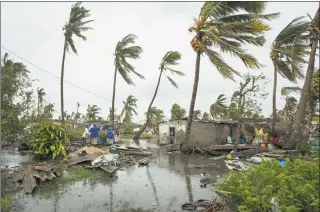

{"left": 111, "top": 34, "right": 144, "bottom": 129}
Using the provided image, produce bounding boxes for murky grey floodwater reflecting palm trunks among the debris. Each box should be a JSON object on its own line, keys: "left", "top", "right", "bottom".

{"left": 1, "top": 141, "right": 227, "bottom": 212}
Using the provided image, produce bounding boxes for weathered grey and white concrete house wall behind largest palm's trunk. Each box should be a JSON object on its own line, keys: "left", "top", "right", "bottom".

{"left": 159, "top": 120, "right": 236, "bottom": 146}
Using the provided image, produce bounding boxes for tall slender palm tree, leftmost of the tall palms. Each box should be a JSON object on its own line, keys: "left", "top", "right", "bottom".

{"left": 61, "top": 2, "right": 93, "bottom": 123}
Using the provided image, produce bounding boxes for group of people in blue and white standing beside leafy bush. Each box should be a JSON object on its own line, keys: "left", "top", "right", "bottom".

{"left": 82, "top": 123, "right": 118, "bottom": 145}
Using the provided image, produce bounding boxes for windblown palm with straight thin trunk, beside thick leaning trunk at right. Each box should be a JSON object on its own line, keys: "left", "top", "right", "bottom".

{"left": 270, "top": 17, "right": 309, "bottom": 135}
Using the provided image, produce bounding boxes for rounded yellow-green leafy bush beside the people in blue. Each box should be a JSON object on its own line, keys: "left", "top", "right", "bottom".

{"left": 31, "top": 124, "right": 68, "bottom": 160}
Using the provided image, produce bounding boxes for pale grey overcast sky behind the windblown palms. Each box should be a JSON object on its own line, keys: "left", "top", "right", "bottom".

{"left": 1, "top": 2, "right": 318, "bottom": 121}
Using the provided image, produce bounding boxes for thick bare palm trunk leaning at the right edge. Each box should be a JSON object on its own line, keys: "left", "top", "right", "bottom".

{"left": 290, "top": 24, "right": 319, "bottom": 144}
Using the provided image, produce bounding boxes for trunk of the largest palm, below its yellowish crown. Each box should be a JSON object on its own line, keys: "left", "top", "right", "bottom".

{"left": 185, "top": 51, "right": 201, "bottom": 144}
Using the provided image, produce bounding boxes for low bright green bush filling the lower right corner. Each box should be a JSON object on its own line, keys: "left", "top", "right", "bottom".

{"left": 217, "top": 159, "right": 319, "bottom": 212}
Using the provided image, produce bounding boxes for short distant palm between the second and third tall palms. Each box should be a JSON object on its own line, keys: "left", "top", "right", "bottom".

{"left": 120, "top": 95, "right": 138, "bottom": 130}
